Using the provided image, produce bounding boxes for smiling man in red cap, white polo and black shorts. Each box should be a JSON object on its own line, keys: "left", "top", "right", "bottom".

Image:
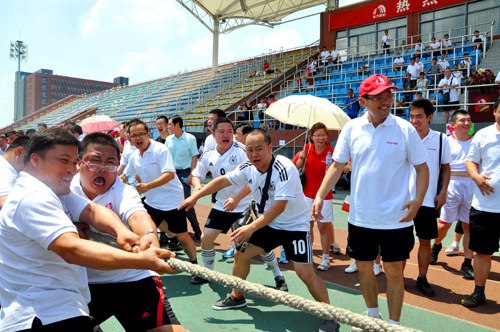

{"left": 311, "top": 74, "right": 429, "bottom": 331}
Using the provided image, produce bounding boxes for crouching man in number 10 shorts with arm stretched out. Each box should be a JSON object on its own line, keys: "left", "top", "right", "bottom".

{"left": 179, "top": 129, "right": 339, "bottom": 332}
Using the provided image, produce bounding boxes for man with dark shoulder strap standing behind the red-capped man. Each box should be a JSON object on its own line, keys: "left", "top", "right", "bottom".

{"left": 410, "top": 98, "right": 451, "bottom": 296}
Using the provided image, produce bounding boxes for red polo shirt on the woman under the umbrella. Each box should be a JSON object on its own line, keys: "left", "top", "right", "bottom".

{"left": 292, "top": 143, "right": 334, "bottom": 200}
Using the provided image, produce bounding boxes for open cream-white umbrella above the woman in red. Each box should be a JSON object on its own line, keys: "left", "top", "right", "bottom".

{"left": 266, "top": 95, "right": 351, "bottom": 130}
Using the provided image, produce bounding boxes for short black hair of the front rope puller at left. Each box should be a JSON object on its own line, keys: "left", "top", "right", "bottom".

{"left": 24, "top": 128, "right": 80, "bottom": 167}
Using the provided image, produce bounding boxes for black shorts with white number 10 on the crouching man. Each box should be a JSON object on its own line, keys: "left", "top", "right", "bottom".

{"left": 248, "top": 226, "right": 312, "bottom": 264}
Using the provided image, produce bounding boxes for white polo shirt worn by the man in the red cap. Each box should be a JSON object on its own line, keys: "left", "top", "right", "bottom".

{"left": 333, "top": 112, "right": 427, "bottom": 229}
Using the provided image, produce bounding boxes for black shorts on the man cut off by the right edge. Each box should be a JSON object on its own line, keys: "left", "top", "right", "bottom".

{"left": 469, "top": 207, "right": 500, "bottom": 255}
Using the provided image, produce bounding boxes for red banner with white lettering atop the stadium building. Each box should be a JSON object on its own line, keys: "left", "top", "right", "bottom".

{"left": 330, "top": 0, "right": 463, "bottom": 31}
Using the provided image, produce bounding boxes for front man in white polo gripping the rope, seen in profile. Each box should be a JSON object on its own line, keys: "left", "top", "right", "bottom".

{"left": 0, "top": 128, "right": 174, "bottom": 332}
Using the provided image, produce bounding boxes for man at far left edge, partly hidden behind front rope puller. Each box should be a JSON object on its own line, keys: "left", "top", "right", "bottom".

{"left": 0, "top": 135, "right": 30, "bottom": 210}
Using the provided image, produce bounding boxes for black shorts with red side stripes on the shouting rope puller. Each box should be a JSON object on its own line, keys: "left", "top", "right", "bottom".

{"left": 89, "top": 276, "right": 180, "bottom": 331}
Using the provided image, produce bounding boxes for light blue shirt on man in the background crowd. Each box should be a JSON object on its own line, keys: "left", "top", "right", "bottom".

{"left": 165, "top": 132, "right": 199, "bottom": 169}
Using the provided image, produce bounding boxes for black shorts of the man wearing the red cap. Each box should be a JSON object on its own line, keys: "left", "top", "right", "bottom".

{"left": 347, "top": 224, "right": 415, "bottom": 262}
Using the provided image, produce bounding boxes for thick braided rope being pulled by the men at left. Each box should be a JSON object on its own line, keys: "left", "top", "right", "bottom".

{"left": 84, "top": 229, "right": 420, "bottom": 332}
